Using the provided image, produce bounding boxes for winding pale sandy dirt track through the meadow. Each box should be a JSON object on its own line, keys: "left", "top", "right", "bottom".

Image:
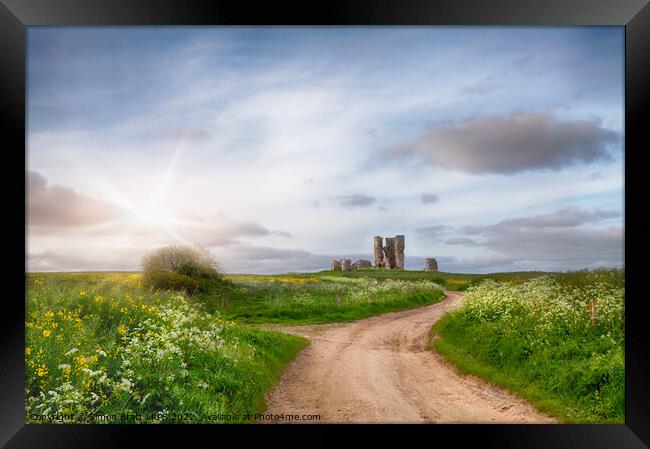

{"left": 260, "top": 292, "right": 555, "bottom": 423}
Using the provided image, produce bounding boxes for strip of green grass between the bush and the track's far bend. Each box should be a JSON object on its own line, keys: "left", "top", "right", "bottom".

{"left": 197, "top": 273, "right": 444, "bottom": 324}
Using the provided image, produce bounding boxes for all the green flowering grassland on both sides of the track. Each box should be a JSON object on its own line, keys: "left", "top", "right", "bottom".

{"left": 25, "top": 270, "right": 624, "bottom": 423}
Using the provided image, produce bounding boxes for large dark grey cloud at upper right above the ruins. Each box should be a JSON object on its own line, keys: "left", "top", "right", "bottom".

{"left": 388, "top": 111, "right": 620, "bottom": 174}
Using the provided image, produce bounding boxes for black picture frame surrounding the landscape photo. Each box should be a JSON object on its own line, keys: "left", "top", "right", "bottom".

{"left": 0, "top": 0, "right": 650, "bottom": 449}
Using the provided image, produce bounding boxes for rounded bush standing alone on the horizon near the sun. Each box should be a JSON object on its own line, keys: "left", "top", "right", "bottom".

{"left": 142, "top": 245, "right": 228, "bottom": 294}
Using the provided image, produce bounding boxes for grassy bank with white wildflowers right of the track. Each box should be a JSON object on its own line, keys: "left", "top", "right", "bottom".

{"left": 430, "top": 270, "right": 625, "bottom": 423}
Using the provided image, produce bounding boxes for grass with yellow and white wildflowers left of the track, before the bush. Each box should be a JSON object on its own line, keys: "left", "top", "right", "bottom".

{"left": 25, "top": 273, "right": 307, "bottom": 423}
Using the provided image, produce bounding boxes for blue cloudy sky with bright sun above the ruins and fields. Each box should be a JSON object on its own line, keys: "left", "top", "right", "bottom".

{"left": 26, "top": 27, "right": 624, "bottom": 273}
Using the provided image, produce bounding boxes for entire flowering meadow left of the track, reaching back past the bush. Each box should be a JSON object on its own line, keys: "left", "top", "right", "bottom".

{"left": 25, "top": 273, "right": 443, "bottom": 423}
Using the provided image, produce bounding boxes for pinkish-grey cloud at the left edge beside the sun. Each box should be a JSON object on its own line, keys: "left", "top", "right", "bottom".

{"left": 27, "top": 170, "right": 129, "bottom": 231}
